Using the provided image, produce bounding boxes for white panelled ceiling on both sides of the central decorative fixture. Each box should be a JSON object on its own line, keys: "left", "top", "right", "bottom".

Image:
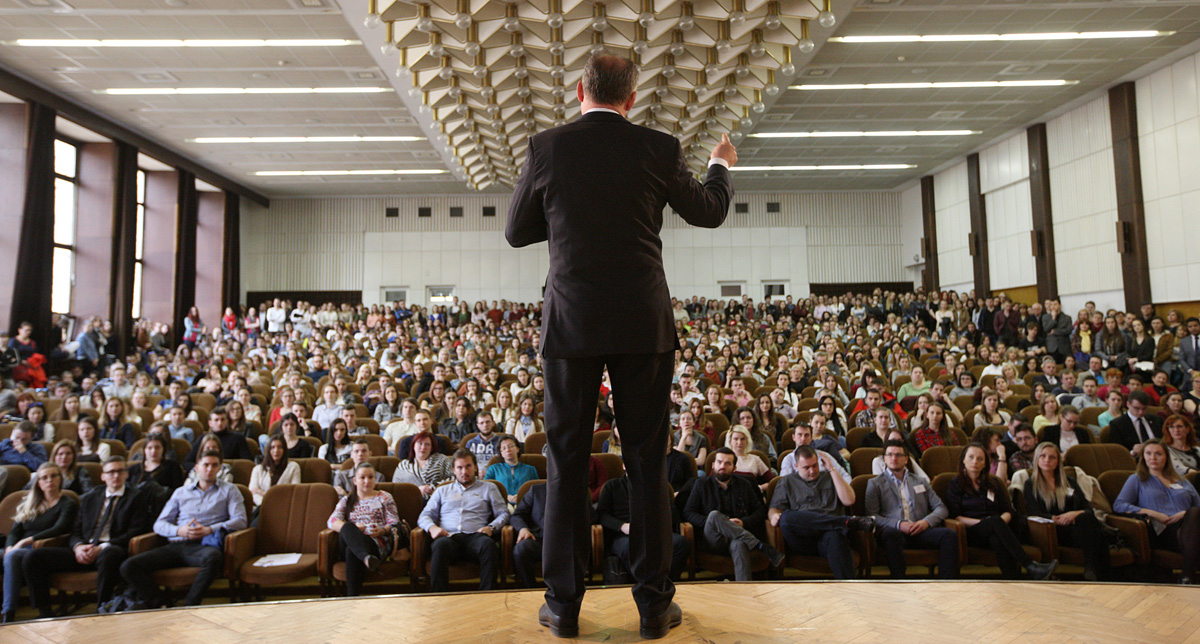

{"left": 0, "top": 0, "right": 1200, "bottom": 197}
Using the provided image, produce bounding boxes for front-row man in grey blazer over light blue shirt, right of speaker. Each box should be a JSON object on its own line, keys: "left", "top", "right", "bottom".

{"left": 866, "top": 440, "right": 959, "bottom": 579}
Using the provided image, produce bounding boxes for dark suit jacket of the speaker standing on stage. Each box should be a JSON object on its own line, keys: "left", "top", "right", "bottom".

{"left": 504, "top": 112, "right": 733, "bottom": 357}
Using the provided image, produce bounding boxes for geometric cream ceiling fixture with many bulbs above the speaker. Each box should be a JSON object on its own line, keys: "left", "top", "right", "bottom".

{"left": 364, "top": 0, "right": 836, "bottom": 189}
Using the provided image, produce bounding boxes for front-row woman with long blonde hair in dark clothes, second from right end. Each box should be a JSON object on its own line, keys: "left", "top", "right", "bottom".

{"left": 1025, "top": 443, "right": 1109, "bottom": 582}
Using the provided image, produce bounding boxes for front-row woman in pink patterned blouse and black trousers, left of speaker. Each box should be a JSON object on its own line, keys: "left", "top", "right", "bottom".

{"left": 325, "top": 463, "right": 408, "bottom": 597}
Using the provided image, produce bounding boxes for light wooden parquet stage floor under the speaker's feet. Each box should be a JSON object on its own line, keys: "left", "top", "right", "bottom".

{"left": 0, "top": 582, "right": 1200, "bottom": 644}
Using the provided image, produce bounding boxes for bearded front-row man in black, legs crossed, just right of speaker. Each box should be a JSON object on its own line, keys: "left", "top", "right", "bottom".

{"left": 684, "top": 447, "right": 784, "bottom": 582}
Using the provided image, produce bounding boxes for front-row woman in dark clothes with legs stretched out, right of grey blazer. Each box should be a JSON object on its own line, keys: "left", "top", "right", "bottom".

{"left": 946, "top": 443, "right": 1058, "bottom": 579}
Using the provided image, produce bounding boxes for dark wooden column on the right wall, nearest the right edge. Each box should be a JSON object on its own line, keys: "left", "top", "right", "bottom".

{"left": 1109, "top": 83, "right": 1152, "bottom": 311}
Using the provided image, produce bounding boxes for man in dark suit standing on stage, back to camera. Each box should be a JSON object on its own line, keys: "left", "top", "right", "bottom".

{"left": 505, "top": 53, "right": 737, "bottom": 638}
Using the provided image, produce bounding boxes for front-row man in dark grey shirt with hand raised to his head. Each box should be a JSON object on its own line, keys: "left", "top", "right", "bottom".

{"left": 767, "top": 445, "right": 874, "bottom": 579}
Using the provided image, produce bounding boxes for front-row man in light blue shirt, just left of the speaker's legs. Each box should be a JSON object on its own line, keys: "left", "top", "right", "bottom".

{"left": 417, "top": 450, "right": 509, "bottom": 592}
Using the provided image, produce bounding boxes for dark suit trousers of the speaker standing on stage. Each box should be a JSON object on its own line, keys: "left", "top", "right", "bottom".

{"left": 542, "top": 351, "right": 674, "bottom": 616}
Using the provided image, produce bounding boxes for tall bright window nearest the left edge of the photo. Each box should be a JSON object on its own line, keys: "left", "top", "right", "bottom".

{"left": 50, "top": 139, "right": 79, "bottom": 313}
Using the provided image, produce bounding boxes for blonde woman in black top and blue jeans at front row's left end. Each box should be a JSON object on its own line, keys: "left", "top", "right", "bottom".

{"left": 0, "top": 462, "right": 79, "bottom": 622}
